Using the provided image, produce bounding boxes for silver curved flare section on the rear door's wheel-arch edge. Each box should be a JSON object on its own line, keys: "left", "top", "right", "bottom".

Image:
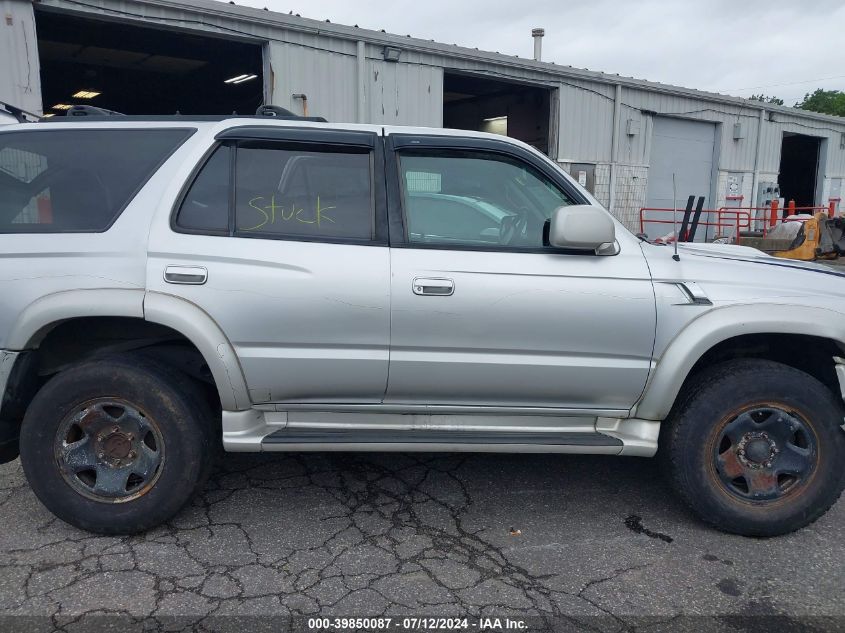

{"left": 144, "top": 292, "right": 251, "bottom": 411}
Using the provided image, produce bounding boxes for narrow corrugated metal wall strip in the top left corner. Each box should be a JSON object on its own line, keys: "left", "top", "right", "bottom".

{"left": 0, "top": 0, "right": 41, "bottom": 114}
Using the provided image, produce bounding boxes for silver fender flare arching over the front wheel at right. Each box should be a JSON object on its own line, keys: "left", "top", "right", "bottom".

{"left": 631, "top": 303, "right": 845, "bottom": 420}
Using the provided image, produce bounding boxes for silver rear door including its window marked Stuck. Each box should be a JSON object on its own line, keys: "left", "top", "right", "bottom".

{"left": 148, "top": 126, "right": 390, "bottom": 403}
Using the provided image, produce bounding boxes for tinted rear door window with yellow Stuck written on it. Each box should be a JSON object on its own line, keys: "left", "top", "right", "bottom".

{"left": 235, "top": 147, "right": 373, "bottom": 240}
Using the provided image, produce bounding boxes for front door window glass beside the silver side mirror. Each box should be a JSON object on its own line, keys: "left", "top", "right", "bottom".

{"left": 400, "top": 152, "right": 573, "bottom": 249}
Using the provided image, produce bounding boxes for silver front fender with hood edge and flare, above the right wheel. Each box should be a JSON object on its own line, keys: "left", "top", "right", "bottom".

{"left": 632, "top": 243, "right": 845, "bottom": 420}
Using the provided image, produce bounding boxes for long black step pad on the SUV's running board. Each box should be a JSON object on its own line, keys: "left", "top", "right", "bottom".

{"left": 261, "top": 427, "right": 624, "bottom": 455}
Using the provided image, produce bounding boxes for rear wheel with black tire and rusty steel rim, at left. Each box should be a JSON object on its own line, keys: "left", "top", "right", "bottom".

{"left": 20, "top": 355, "right": 215, "bottom": 534}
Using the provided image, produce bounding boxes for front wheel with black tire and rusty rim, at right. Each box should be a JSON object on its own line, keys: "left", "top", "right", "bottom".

{"left": 660, "top": 359, "right": 845, "bottom": 537}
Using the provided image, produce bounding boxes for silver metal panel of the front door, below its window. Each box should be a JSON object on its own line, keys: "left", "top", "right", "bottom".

{"left": 385, "top": 247, "right": 655, "bottom": 409}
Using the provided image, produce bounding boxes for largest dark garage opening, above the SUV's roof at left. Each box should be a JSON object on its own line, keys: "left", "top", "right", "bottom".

{"left": 36, "top": 11, "right": 264, "bottom": 115}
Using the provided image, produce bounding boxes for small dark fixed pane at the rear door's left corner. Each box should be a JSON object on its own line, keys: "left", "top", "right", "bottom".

{"left": 176, "top": 147, "right": 232, "bottom": 232}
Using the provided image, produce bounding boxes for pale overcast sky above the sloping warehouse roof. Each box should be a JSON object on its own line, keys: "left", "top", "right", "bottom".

{"left": 221, "top": 0, "right": 845, "bottom": 105}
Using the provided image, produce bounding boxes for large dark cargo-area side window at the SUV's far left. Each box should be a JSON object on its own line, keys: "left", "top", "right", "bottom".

{"left": 0, "top": 128, "right": 193, "bottom": 233}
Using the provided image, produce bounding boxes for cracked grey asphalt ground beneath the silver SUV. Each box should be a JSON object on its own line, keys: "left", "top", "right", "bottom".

{"left": 0, "top": 453, "right": 845, "bottom": 631}
